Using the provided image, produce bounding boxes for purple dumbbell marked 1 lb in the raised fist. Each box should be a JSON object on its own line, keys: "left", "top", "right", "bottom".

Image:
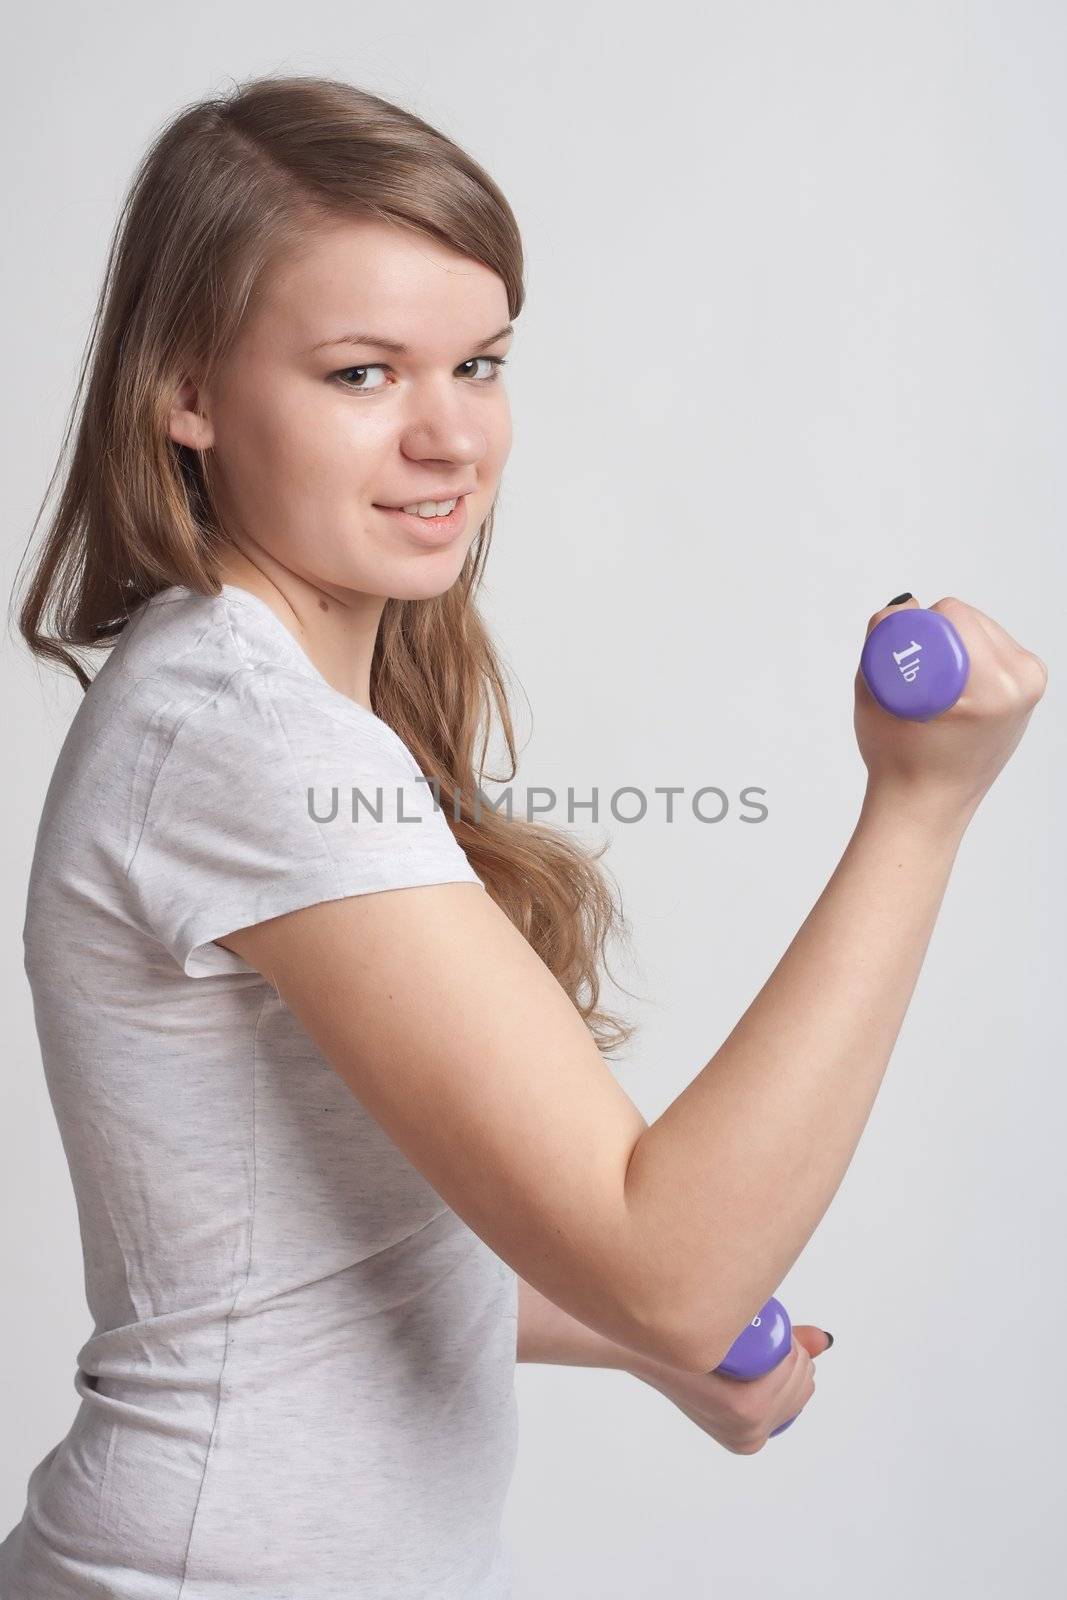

{"left": 859, "top": 606, "right": 971, "bottom": 722}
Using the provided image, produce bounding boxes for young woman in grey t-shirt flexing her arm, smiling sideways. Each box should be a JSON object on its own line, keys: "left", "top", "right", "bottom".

{"left": 0, "top": 68, "right": 1045, "bottom": 1600}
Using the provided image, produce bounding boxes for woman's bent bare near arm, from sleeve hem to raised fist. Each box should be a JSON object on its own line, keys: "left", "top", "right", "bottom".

{"left": 218, "top": 600, "right": 1045, "bottom": 1371}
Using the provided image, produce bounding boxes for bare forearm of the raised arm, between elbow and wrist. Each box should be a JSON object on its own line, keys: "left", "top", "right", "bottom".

{"left": 627, "top": 780, "right": 966, "bottom": 1368}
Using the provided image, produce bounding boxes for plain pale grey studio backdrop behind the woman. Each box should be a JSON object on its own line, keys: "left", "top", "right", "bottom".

{"left": 0, "top": 0, "right": 1067, "bottom": 1600}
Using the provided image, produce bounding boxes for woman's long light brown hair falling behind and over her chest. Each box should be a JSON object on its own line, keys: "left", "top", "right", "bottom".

{"left": 12, "top": 77, "right": 635, "bottom": 1054}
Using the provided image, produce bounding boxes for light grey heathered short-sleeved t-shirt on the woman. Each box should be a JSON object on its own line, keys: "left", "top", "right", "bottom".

{"left": 0, "top": 584, "right": 518, "bottom": 1600}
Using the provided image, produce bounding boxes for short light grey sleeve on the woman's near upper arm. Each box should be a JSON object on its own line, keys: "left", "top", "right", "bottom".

{"left": 126, "top": 669, "right": 482, "bottom": 978}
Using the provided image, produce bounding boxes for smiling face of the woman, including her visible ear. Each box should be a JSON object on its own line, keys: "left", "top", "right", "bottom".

{"left": 171, "top": 219, "right": 512, "bottom": 600}
